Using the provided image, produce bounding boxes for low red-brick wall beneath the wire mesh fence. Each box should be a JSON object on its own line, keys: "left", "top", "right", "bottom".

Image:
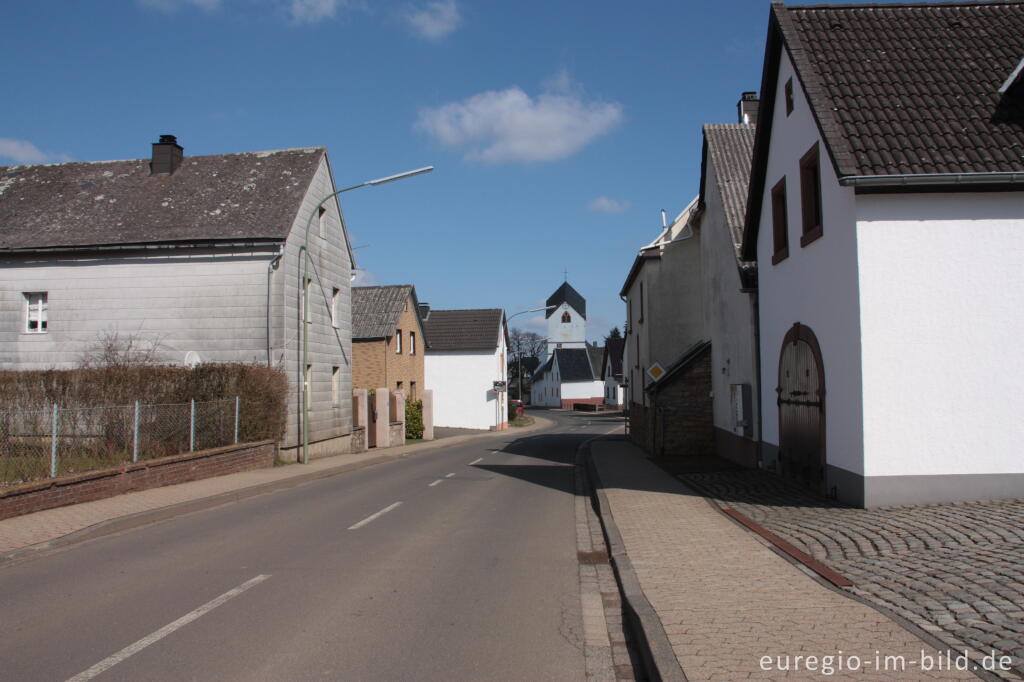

{"left": 0, "top": 440, "right": 276, "bottom": 519}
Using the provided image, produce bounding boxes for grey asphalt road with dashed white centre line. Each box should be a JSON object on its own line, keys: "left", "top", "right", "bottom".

{"left": 0, "top": 405, "right": 618, "bottom": 681}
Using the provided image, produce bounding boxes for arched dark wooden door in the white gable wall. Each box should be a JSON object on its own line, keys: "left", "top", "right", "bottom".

{"left": 775, "top": 323, "right": 825, "bottom": 494}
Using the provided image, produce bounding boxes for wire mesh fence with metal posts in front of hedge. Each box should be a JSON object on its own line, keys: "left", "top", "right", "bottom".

{"left": 0, "top": 398, "right": 241, "bottom": 486}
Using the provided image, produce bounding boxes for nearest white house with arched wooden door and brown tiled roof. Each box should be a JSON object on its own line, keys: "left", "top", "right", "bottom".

{"left": 741, "top": 2, "right": 1024, "bottom": 507}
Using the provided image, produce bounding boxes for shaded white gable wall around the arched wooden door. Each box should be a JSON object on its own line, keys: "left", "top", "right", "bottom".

{"left": 758, "top": 50, "right": 863, "bottom": 477}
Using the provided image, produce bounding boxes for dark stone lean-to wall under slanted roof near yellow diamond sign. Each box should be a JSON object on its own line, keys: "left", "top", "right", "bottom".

{"left": 630, "top": 345, "right": 715, "bottom": 458}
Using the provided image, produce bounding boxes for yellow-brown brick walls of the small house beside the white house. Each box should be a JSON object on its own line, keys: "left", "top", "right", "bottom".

{"left": 352, "top": 296, "right": 426, "bottom": 400}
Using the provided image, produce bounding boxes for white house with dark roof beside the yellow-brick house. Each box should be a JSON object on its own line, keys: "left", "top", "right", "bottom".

{"left": 421, "top": 306, "right": 508, "bottom": 430}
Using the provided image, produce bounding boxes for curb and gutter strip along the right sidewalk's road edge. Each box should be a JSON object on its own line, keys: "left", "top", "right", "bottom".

{"left": 581, "top": 438, "right": 687, "bottom": 682}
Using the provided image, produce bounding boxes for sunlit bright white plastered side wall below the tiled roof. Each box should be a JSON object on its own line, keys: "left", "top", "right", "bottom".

{"left": 856, "top": 193, "right": 1024, "bottom": 476}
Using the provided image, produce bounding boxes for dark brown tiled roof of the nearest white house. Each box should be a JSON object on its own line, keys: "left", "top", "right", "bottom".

{"left": 774, "top": 0, "right": 1024, "bottom": 177}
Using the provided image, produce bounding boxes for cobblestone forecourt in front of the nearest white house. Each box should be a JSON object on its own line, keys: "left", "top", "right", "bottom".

{"left": 679, "top": 471, "right": 1024, "bottom": 679}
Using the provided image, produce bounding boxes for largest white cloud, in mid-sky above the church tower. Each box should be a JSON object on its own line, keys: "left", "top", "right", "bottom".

{"left": 416, "top": 74, "right": 623, "bottom": 164}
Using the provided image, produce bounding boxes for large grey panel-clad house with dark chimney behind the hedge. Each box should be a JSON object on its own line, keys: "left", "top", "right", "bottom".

{"left": 0, "top": 135, "right": 354, "bottom": 458}
